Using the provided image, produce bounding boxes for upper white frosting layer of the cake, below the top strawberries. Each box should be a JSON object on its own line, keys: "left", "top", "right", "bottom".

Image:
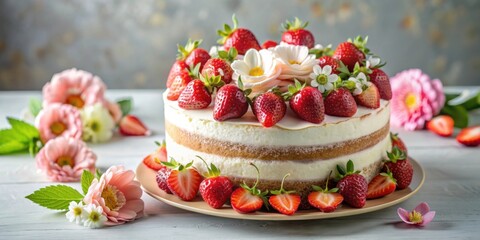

{"left": 164, "top": 92, "right": 390, "bottom": 146}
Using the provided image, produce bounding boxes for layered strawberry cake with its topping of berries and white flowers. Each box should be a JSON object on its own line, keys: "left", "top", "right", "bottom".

{"left": 163, "top": 15, "right": 392, "bottom": 202}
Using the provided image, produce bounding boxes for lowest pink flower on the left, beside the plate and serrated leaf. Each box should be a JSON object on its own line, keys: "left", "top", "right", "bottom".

{"left": 83, "top": 166, "right": 144, "bottom": 225}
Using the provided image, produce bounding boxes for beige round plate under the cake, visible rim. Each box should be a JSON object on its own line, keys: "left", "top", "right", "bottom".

{"left": 137, "top": 159, "right": 425, "bottom": 221}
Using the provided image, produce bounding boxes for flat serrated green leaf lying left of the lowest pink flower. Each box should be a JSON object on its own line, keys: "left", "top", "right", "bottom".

{"left": 25, "top": 185, "right": 83, "bottom": 210}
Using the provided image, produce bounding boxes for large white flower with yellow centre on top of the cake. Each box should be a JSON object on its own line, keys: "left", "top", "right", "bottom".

{"left": 232, "top": 49, "right": 281, "bottom": 94}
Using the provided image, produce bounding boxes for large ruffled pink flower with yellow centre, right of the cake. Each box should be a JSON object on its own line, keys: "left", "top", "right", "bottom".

{"left": 391, "top": 69, "right": 445, "bottom": 130}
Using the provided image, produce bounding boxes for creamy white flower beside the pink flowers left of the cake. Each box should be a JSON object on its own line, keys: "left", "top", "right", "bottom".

{"left": 81, "top": 103, "right": 115, "bottom": 143}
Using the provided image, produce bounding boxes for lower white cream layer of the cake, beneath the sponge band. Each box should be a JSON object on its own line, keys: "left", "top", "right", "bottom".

{"left": 166, "top": 134, "right": 391, "bottom": 181}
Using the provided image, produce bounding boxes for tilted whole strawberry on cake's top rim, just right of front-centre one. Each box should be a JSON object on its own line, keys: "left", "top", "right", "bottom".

{"left": 285, "top": 80, "right": 325, "bottom": 123}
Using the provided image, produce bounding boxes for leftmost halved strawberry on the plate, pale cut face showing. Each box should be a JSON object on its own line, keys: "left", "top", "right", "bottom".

{"left": 162, "top": 159, "right": 203, "bottom": 201}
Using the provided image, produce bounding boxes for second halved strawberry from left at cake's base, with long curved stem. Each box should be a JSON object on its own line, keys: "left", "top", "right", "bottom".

{"left": 230, "top": 163, "right": 268, "bottom": 213}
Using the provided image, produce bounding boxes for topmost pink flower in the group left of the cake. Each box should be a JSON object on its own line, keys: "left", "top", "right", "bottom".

{"left": 43, "top": 68, "right": 106, "bottom": 108}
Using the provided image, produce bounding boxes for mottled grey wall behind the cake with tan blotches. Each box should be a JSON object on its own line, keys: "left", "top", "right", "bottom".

{"left": 0, "top": 0, "right": 480, "bottom": 90}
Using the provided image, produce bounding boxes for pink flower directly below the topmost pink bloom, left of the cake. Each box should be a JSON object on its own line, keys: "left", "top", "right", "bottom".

{"left": 35, "top": 103, "right": 82, "bottom": 143}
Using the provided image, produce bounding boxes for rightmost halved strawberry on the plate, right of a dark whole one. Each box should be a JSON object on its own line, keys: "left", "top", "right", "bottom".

{"left": 367, "top": 172, "right": 397, "bottom": 199}
